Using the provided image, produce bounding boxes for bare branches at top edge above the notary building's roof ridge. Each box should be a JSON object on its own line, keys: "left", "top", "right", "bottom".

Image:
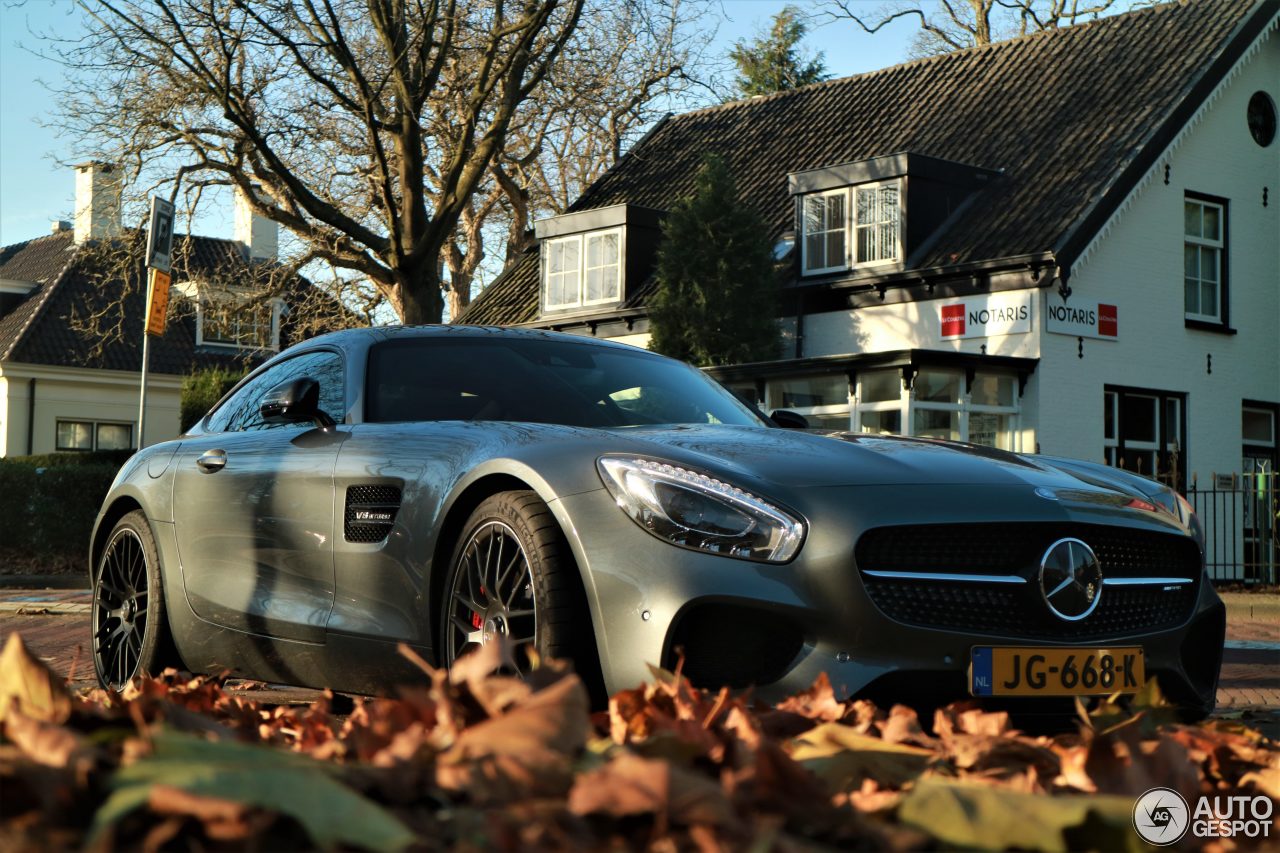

{"left": 818, "top": 0, "right": 1116, "bottom": 58}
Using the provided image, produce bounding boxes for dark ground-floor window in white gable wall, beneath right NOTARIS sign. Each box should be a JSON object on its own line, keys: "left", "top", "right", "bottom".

{"left": 1102, "top": 387, "right": 1187, "bottom": 489}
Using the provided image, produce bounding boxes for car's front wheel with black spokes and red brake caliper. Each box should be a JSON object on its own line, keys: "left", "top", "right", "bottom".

{"left": 440, "top": 491, "right": 604, "bottom": 701}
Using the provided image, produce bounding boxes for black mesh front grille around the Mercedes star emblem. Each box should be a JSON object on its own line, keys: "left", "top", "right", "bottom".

{"left": 855, "top": 524, "right": 1201, "bottom": 640}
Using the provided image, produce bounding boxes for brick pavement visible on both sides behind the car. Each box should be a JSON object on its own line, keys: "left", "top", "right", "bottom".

{"left": 0, "top": 589, "right": 1280, "bottom": 713}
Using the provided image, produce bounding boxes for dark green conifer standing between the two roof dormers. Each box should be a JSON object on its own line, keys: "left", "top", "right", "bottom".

{"left": 649, "top": 155, "right": 781, "bottom": 366}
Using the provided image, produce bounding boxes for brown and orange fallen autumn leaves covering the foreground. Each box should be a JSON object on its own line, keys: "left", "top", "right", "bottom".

{"left": 0, "top": 637, "right": 1280, "bottom": 850}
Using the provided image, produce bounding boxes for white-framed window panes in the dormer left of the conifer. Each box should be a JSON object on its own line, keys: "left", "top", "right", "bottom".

{"left": 543, "top": 228, "right": 622, "bottom": 309}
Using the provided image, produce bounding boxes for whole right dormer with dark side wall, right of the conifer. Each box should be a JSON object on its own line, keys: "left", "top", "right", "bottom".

{"left": 788, "top": 152, "right": 997, "bottom": 275}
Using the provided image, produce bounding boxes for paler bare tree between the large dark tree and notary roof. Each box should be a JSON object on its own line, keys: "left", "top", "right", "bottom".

{"left": 443, "top": 0, "right": 718, "bottom": 318}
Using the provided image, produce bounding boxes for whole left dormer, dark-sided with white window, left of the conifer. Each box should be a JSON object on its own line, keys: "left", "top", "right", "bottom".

{"left": 534, "top": 205, "right": 662, "bottom": 316}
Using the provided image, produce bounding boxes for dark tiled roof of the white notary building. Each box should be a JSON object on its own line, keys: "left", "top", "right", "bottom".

{"left": 461, "top": 0, "right": 1280, "bottom": 324}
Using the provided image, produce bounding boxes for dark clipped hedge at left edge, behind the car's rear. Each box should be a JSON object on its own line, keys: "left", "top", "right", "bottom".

{"left": 0, "top": 453, "right": 128, "bottom": 566}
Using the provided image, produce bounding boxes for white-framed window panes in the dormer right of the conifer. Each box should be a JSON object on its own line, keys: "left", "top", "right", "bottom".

{"left": 800, "top": 181, "right": 902, "bottom": 273}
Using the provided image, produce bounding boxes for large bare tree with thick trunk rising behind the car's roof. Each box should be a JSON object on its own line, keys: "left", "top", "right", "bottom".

{"left": 45, "top": 0, "right": 584, "bottom": 323}
